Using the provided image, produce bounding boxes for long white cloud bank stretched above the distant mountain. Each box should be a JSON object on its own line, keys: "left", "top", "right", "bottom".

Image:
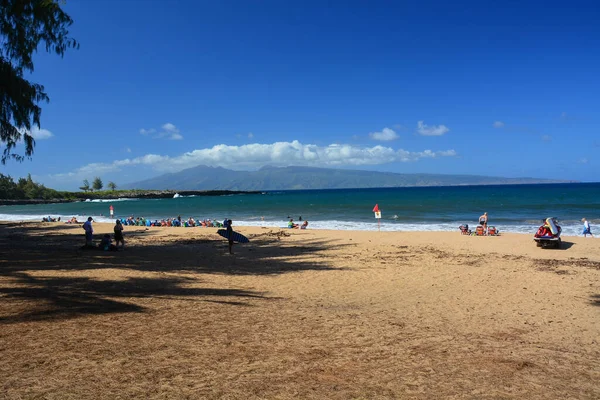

{"left": 52, "top": 140, "right": 457, "bottom": 179}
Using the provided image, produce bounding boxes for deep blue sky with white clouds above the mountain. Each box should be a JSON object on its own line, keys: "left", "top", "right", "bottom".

{"left": 0, "top": 0, "right": 600, "bottom": 189}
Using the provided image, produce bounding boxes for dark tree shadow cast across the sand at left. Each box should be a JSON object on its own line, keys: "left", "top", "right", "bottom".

{"left": 0, "top": 223, "right": 340, "bottom": 324}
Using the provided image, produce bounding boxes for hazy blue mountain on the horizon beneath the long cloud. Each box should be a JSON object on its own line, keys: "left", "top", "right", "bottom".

{"left": 122, "top": 165, "right": 567, "bottom": 190}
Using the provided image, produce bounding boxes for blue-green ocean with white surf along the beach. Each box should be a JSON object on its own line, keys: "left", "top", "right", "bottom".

{"left": 0, "top": 183, "right": 600, "bottom": 236}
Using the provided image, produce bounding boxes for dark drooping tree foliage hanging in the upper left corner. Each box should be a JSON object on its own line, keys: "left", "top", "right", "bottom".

{"left": 0, "top": 0, "right": 79, "bottom": 164}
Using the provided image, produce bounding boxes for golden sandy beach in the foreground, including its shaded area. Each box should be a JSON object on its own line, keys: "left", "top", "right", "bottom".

{"left": 0, "top": 223, "right": 600, "bottom": 399}
